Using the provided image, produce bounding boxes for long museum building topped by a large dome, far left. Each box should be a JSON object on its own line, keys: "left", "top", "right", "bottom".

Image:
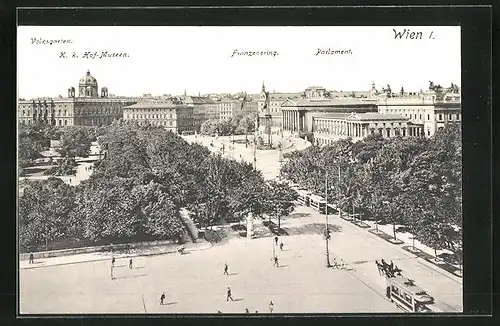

{"left": 18, "top": 71, "right": 135, "bottom": 126}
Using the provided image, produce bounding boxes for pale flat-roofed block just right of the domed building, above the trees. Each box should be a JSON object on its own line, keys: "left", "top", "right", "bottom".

{"left": 123, "top": 100, "right": 195, "bottom": 134}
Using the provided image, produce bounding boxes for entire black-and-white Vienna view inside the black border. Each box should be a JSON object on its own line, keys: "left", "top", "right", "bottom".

{"left": 17, "top": 22, "right": 464, "bottom": 316}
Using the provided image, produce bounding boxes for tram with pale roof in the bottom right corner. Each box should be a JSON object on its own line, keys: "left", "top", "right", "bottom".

{"left": 386, "top": 276, "right": 456, "bottom": 313}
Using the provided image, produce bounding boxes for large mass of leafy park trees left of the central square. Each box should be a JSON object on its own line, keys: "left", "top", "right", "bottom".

{"left": 19, "top": 121, "right": 295, "bottom": 249}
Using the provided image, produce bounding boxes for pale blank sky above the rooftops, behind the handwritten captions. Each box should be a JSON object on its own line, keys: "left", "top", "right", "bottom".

{"left": 17, "top": 26, "right": 461, "bottom": 99}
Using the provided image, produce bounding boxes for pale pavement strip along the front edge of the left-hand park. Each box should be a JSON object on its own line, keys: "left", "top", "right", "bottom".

{"left": 19, "top": 239, "right": 212, "bottom": 269}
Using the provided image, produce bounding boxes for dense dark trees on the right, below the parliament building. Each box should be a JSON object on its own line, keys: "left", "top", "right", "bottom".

{"left": 281, "top": 125, "right": 462, "bottom": 252}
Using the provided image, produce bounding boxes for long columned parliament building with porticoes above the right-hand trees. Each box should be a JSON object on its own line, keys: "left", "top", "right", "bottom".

{"left": 259, "top": 83, "right": 461, "bottom": 145}
